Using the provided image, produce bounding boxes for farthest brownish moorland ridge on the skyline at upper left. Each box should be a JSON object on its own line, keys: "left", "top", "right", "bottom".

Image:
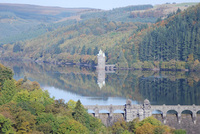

{"left": 0, "top": 4, "right": 90, "bottom": 22}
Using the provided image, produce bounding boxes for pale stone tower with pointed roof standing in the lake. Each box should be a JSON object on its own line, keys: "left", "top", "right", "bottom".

{"left": 97, "top": 50, "right": 106, "bottom": 70}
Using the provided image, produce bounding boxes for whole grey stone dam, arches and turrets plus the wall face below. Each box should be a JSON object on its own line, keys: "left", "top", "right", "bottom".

{"left": 84, "top": 100, "right": 200, "bottom": 134}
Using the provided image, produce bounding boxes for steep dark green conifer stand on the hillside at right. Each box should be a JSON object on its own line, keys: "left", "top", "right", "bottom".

{"left": 139, "top": 4, "right": 200, "bottom": 69}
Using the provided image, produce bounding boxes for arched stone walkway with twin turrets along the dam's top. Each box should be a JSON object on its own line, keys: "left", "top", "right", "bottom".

{"left": 84, "top": 99, "right": 200, "bottom": 124}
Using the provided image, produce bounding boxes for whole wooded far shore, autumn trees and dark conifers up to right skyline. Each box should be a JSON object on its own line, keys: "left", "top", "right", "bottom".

{"left": 0, "top": 4, "right": 200, "bottom": 70}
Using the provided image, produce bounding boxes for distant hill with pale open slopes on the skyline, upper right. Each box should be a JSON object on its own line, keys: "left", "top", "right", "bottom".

{"left": 81, "top": 3, "right": 197, "bottom": 23}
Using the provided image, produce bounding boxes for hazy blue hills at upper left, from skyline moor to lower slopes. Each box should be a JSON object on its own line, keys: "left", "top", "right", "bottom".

{"left": 0, "top": 4, "right": 95, "bottom": 44}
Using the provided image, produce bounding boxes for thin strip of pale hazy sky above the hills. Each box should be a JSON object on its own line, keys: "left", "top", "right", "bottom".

{"left": 0, "top": 0, "right": 200, "bottom": 9}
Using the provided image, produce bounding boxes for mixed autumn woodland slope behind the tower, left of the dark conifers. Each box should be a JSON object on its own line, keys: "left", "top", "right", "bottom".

{"left": 1, "top": 19, "right": 141, "bottom": 67}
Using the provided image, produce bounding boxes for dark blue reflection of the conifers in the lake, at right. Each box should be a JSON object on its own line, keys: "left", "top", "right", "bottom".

{"left": 139, "top": 76, "right": 200, "bottom": 105}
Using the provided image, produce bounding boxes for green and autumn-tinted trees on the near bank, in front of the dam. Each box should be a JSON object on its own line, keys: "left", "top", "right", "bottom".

{"left": 0, "top": 64, "right": 188, "bottom": 134}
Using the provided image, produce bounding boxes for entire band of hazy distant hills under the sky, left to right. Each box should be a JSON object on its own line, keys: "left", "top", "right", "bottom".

{"left": 0, "top": 3, "right": 195, "bottom": 44}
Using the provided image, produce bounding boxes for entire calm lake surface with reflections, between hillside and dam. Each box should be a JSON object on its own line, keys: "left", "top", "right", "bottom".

{"left": 2, "top": 61, "right": 200, "bottom": 105}
